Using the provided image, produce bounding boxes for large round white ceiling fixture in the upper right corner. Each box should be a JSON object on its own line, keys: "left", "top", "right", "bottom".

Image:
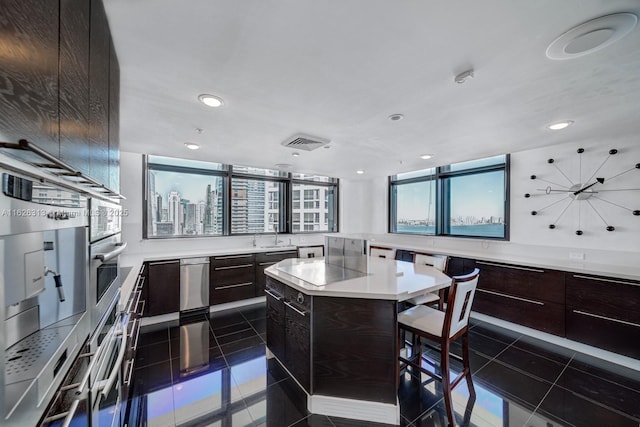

{"left": 546, "top": 12, "right": 638, "bottom": 59}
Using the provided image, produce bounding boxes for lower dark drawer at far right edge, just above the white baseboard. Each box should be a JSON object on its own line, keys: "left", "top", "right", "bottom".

{"left": 566, "top": 308, "right": 640, "bottom": 359}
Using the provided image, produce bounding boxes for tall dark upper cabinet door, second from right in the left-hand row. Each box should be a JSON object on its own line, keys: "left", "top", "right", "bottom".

{"left": 89, "top": 0, "right": 109, "bottom": 186}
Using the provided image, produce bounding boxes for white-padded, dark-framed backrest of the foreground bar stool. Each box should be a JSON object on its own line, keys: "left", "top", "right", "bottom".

{"left": 442, "top": 268, "right": 480, "bottom": 338}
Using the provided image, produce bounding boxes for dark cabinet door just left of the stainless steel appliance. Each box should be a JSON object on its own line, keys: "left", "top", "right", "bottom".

{"left": 146, "top": 260, "right": 180, "bottom": 316}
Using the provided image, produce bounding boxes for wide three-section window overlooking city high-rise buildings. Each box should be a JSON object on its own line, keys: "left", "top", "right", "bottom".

{"left": 144, "top": 156, "right": 338, "bottom": 238}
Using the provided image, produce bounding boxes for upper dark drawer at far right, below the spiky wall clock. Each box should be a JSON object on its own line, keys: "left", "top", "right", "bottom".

{"left": 567, "top": 273, "right": 640, "bottom": 324}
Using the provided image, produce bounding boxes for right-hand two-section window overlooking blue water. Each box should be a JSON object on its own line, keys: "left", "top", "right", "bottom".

{"left": 389, "top": 156, "right": 509, "bottom": 239}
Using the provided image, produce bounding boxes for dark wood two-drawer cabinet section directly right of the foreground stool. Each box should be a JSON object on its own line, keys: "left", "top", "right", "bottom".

{"left": 473, "top": 261, "right": 565, "bottom": 336}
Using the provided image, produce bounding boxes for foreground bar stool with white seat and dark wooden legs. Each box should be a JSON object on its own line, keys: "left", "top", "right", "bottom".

{"left": 398, "top": 268, "right": 480, "bottom": 426}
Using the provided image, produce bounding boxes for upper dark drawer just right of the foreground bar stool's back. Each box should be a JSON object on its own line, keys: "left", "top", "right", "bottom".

{"left": 476, "top": 261, "right": 565, "bottom": 304}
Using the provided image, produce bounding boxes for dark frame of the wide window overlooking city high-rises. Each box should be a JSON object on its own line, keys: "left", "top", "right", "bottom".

{"left": 142, "top": 154, "right": 340, "bottom": 240}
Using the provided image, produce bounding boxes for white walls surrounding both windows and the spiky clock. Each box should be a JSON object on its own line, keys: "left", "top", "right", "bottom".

{"left": 121, "top": 138, "right": 640, "bottom": 267}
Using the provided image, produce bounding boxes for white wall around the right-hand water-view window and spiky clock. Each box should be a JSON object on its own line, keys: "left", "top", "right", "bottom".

{"left": 341, "top": 138, "right": 640, "bottom": 267}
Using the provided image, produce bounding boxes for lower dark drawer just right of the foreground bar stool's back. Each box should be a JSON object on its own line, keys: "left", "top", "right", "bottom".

{"left": 472, "top": 288, "right": 565, "bottom": 336}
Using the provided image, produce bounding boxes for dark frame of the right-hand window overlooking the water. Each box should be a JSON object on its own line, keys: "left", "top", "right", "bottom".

{"left": 387, "top": 154, "right": 511, "bottom": 241}
